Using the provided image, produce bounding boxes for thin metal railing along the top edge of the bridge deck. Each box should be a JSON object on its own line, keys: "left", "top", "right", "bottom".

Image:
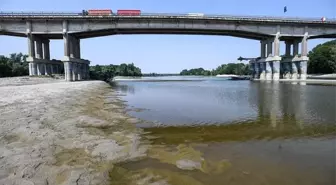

{"left": 0, "top": 11, "right": 336, "bottom": 23}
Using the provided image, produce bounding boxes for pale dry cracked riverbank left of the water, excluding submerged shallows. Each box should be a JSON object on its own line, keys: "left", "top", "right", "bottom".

{"left": 0, "top": 77, "right": 146, "bottom": 185}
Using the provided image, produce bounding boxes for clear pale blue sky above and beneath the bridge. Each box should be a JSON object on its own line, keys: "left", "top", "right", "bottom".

{"left": 0, "top": 0, "right": 336, "bottom": 73}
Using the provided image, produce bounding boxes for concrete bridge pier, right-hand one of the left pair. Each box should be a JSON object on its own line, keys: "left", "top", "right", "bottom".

{"left": 62, "top": 21, "right": 90, "bottom": 82}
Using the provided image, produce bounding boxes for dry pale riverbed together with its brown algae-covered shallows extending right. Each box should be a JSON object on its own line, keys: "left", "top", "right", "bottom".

{"left": 0, "top": 77, "right": 231, "bottom": 185}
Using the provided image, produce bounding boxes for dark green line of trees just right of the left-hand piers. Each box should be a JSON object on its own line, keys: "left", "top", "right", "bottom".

{"left": 90, "top": 63, "right": 142, "bottom": 81}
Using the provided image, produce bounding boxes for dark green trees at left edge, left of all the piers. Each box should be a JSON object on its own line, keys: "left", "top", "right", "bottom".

{"left": 0, "top": 53, "right": 29, "bottom": 77}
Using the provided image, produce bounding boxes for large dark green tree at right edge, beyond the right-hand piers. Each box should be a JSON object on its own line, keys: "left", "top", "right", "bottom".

{"left": 307, "top": 40, "right": 336, "bottom": 74}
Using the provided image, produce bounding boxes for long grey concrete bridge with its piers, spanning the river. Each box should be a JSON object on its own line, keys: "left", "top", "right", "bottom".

{"left": 0, "top": 12, "right": 336, "bottom": 81}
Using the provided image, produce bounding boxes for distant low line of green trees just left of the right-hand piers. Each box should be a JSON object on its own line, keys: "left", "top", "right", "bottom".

{"left": 180, "top": 63, "right": 249, "bottom": 76}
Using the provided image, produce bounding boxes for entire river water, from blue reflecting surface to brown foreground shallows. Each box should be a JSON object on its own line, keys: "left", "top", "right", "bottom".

{"left": 110, "top": 78, "right": 336, "bottom": 185}
